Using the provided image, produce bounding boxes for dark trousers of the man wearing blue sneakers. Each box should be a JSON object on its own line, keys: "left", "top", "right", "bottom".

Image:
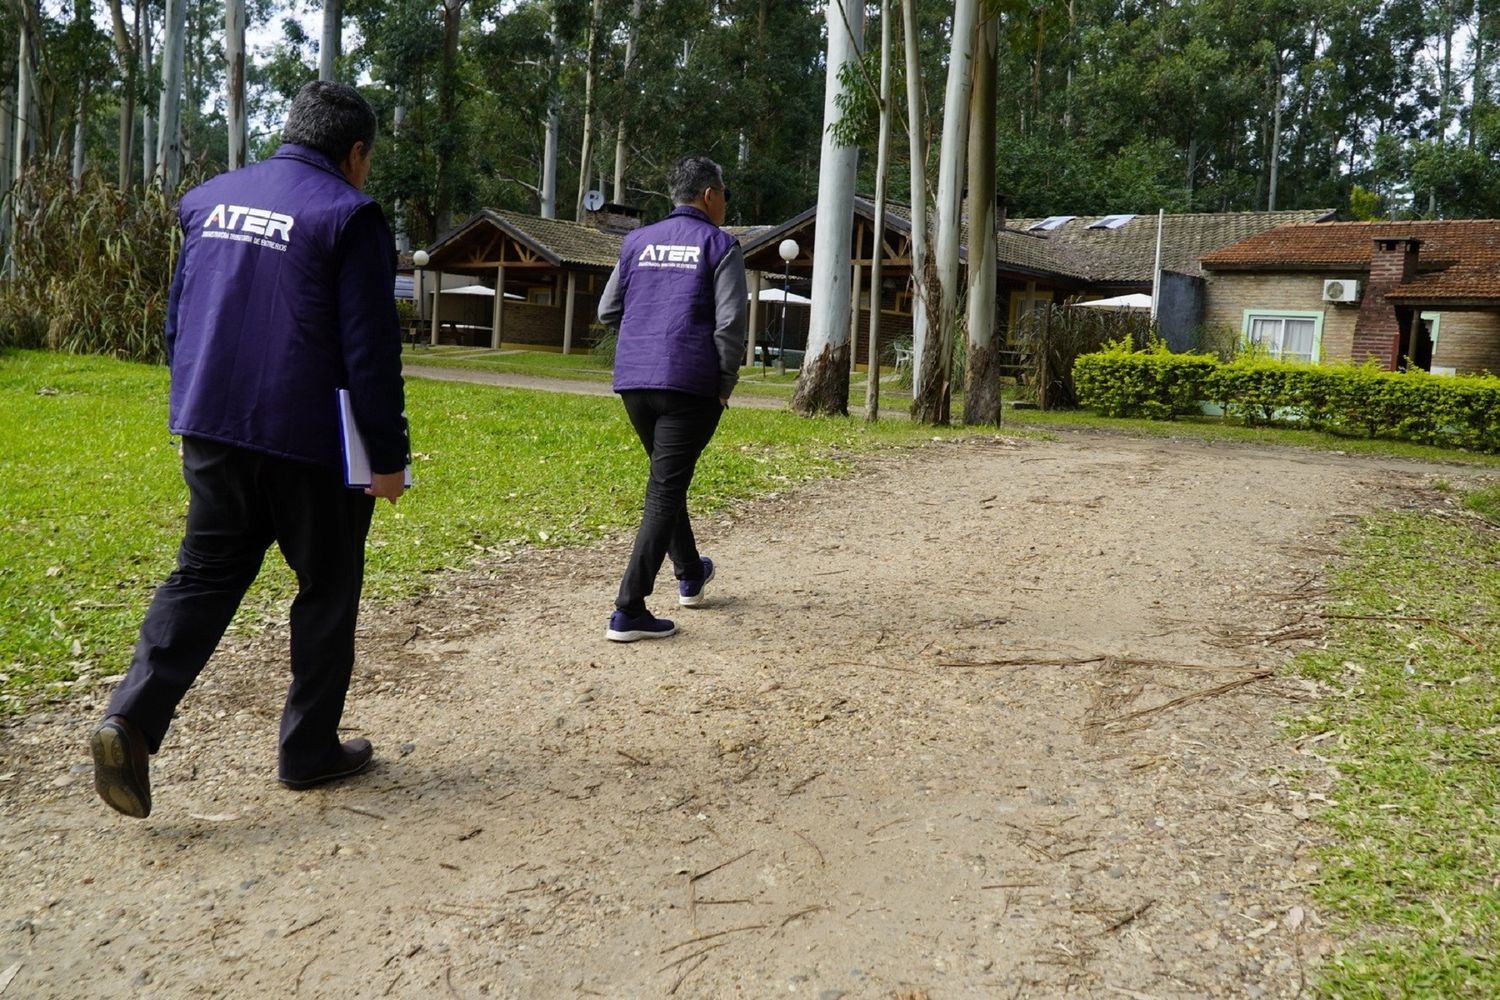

{"left": 615, "top": 390, "right": 725, "bottom": 612}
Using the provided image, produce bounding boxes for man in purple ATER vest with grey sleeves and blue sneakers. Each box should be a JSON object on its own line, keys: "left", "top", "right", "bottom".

{"left": 599, "top": 156, "right": 747, "bottom": 642}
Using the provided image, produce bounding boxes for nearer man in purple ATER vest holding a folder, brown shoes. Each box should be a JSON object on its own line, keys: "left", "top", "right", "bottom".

{"left": 92, "top": 81, "right": 408, "bottom": 819}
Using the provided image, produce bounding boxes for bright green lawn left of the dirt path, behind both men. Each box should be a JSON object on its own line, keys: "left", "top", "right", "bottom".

{"left": 0, "top": 352, "right": 963, "bottom": 712}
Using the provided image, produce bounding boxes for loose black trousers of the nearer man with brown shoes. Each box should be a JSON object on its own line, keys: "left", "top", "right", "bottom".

{"left": 108, "top": 438, "right": 375, "bottom": 774}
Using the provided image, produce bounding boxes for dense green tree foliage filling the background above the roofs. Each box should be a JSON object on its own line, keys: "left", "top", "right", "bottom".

{"left": 0, "top": 0, "right": 1500, "bottom": 243}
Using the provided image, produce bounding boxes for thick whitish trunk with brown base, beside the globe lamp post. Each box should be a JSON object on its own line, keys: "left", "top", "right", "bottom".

{"left": 792, "top": 0, "right": 864, "bottom": 417}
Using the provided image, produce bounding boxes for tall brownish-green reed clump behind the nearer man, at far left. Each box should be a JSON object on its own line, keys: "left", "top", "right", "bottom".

{"left": 0, "top": 160, "right": 182, "bottom": 361}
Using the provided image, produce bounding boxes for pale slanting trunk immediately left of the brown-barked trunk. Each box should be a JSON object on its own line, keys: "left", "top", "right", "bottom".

{"left": 912, "top": 0, "right": 980, "bottom": 424}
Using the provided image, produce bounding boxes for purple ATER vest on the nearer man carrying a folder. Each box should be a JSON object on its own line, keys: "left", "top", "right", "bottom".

{"left": 167, "top": 144, "right": 399, "bottom": 466}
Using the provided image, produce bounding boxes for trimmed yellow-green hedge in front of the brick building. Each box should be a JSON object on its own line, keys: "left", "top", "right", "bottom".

{"left": 1074, "top": 346, "right": 1500, "bottom": 451}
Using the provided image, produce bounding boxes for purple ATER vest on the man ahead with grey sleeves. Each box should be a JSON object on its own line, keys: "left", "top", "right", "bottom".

{"left": 615, "top": 205, "right": 735, "bottom": 399}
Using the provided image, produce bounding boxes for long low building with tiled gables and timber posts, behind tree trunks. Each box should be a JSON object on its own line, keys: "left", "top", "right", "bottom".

{"left": 419, "top": 198, "right": 1362, "bottom": 370}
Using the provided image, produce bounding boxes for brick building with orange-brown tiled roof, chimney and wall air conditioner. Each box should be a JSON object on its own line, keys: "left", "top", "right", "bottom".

{"left": 1202, "top": 219, "right": 1500, "bottom": 373}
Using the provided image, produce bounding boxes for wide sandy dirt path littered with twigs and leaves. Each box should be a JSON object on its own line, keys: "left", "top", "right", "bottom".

{"left": 0, "top": 436, "right": 1466, "bottom": 1000}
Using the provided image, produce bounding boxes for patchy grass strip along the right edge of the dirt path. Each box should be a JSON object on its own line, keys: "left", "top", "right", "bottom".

{"left": 1290, "top": 503, "right": 1500, "bottom": 1000}
